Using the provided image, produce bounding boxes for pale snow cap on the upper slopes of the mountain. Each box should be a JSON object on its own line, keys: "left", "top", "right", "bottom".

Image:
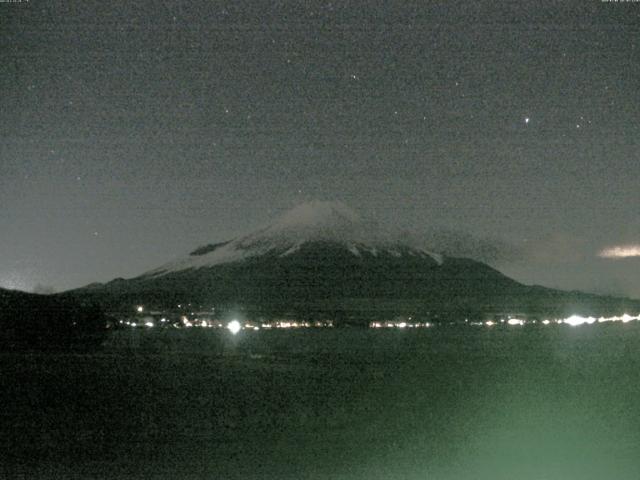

{"left": 142, "top": 201, "right": 442, "bottom": 276}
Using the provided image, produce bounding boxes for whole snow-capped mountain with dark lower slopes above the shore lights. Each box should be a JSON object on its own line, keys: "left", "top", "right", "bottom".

{"left": 66, "top": 201, "right": 640, "bottom": 320}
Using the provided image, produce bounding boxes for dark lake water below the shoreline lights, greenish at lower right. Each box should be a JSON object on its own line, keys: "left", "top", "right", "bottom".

{"left": 0, "top": 324, "right": 640, "bottom": 480}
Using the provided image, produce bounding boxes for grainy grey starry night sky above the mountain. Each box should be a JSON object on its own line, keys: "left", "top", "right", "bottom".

{"left": 0, "top": 0, "right": 640, "bottom": 297}
